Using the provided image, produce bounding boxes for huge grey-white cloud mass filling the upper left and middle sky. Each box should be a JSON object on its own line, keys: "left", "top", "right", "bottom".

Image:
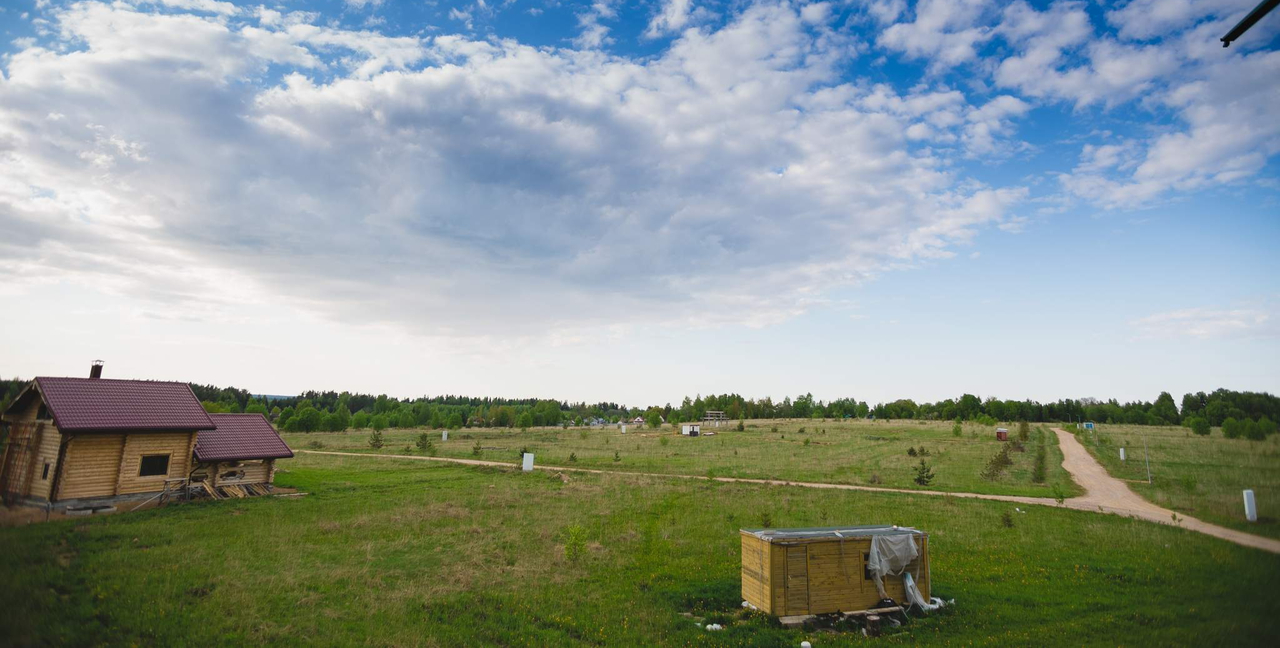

{"left": 0, "top": 4, "right": 1027, "bottom": 338}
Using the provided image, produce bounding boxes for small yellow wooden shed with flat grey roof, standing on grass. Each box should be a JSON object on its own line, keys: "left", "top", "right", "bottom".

{"left": 741, "top": 526, "right": 931, "bottom": 616}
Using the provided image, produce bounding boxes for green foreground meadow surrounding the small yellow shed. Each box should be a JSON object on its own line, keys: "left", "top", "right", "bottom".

{"left": 0, "top": 453, "right": 1280, "bottom": 645}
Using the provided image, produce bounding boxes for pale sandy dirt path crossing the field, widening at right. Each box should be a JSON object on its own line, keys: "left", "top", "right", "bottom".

{"left": 298, "top": 428, "right": 1280, "bottom": 553}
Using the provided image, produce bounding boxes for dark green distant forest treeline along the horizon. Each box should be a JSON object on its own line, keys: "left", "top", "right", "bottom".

{"left": 0, "top": 379, "right": 1280, "bottom": 438}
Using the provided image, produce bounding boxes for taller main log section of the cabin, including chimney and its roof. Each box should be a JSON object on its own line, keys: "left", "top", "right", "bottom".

{"left": 0, "top": 365, "right": 214, "bottom": 503}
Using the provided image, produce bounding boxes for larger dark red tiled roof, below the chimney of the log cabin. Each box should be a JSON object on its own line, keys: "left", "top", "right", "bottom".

{"left": 36, "top": 378, "right": 214, "bottom": 433}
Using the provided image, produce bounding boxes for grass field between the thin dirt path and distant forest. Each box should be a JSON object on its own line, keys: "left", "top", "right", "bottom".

{"left": 284, "top": 420, "right": 1080, "bottom": 497}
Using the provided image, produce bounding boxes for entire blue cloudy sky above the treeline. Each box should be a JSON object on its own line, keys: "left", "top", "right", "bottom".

{"left": 0, "top": 0, "right": 1280, "bottom": 405}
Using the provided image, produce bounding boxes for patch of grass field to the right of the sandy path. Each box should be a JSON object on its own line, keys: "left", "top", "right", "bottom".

{"left": 1064, "top": 425, "right": 1280, "bottom": 538}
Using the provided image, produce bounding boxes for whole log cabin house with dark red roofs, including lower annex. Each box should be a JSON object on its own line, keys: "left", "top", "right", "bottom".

{"left": 0, "top": 362, "right": 293, "bottom": 507}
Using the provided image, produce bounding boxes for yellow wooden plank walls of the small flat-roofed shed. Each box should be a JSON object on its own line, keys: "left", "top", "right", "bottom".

{"left": 742, "top": 533, "right": 931, "bottom": 616}
